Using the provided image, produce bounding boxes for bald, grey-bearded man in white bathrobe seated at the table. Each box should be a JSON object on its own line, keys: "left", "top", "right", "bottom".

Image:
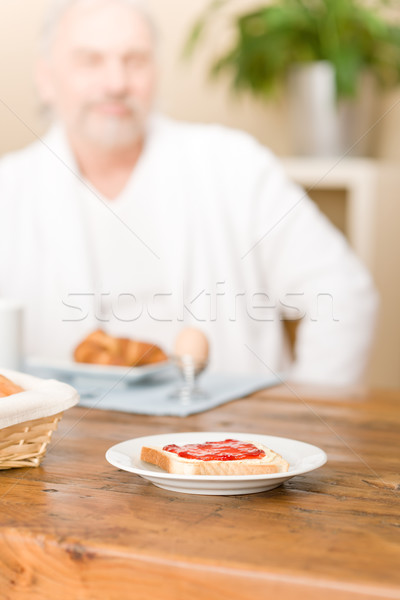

{"left": 0, "top": 0, "right": 377, "bottom": 384}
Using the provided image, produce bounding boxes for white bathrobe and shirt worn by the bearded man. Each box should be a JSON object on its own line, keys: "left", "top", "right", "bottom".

{"left": 0, "top": 117, "right": 377, "bottom": 384}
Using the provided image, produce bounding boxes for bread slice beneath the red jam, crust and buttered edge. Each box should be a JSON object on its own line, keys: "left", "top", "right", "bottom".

{"left": 140, "top": 442, "right": 289, "bottom": 475}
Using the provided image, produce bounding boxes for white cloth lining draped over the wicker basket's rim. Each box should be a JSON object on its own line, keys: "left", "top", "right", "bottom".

{"left": 0, "top": 369, "right": 79, "bottom": 429}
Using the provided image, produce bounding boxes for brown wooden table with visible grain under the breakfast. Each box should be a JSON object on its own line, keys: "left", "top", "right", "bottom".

{"left": 0, "top": 390, "right": 400, "bottom": 600}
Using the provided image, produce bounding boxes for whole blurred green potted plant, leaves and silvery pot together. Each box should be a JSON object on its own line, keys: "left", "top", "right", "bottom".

{"left": 186, "top": 0, "right": 400, "bottom": 154}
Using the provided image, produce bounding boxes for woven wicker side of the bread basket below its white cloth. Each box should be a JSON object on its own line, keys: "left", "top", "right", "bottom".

{"left": 0, "top": 413, "right": 63, "bottom": 470}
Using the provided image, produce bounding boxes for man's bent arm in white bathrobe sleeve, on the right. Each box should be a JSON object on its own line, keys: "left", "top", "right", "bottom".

{"left": 253, "top": 156, "right": 378, "bottom": 385}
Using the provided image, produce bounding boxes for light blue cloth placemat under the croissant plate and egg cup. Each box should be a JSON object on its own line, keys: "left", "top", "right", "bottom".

{"left": 72, "top": 373, "right": 282, "bottom": 417}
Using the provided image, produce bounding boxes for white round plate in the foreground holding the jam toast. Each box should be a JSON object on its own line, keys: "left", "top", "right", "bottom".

{"left": 106, "top": 432, "right": 327, "bottom": 496}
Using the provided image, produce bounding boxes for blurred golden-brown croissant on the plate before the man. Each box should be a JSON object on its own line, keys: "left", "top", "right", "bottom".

{"left": 74, "top": 329, "right": 167, "bottom": 367}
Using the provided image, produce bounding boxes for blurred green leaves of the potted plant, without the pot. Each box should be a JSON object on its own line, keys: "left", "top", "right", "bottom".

{"left": 188, "top": 0, "right": 400, "bottom": 97}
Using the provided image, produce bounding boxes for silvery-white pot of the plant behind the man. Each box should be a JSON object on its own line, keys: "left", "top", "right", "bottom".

{"left": 287, "top": 61, "right": 377, "bottom": 156}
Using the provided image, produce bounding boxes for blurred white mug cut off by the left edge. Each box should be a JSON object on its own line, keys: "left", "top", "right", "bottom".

{"left": 0, "top": 298, "right": 23, "bottom": 371}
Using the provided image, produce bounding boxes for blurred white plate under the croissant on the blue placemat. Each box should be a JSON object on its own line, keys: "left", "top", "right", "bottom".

{"left": 25, "top": 357, "right": 172, "bottom": 383}
